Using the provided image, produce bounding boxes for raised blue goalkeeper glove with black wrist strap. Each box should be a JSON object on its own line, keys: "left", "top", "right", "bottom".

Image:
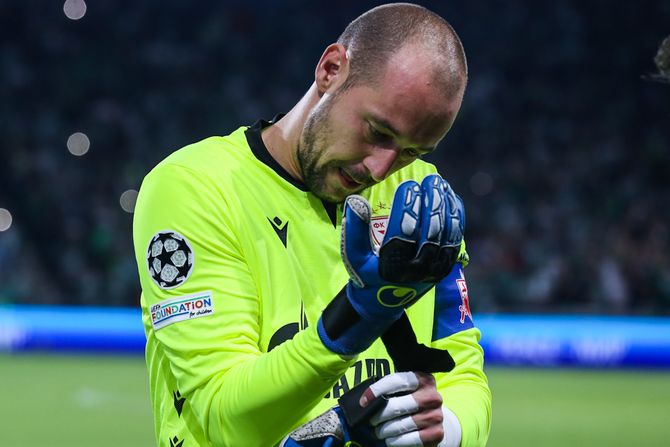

{"left": 318, "top": 175, "right": 465, "bottom": 355}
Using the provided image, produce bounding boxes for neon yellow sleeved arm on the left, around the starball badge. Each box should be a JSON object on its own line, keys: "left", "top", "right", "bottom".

{"left": 134, "top": 165, "right": 353, "bottom": 446}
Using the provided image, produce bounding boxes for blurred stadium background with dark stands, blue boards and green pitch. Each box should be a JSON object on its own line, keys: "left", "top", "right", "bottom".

{"left": 0, "top": 0, "right": 670, "bottom": 447}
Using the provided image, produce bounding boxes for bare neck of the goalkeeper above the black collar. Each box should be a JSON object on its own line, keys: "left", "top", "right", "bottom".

{"left": 261, "top": 84, "right": 319, "bottom": 182}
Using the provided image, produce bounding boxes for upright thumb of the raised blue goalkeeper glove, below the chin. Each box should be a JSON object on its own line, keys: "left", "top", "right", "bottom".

{"left": 340, "top": 195, "right": 373, "bottom": 287}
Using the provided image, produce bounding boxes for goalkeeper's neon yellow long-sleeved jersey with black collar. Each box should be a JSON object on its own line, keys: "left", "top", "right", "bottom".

{"left": 133, "top": 122, "right": 491, "bottom": 447}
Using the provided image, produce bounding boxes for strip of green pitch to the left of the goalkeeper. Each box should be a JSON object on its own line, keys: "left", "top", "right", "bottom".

{"left": 0, "top": 355, "right": 155, "bottom": 447}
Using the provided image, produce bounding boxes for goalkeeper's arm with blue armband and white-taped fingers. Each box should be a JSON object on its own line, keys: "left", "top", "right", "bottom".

{"left": 312, "top": 264, "right": 491, "bottom": 447}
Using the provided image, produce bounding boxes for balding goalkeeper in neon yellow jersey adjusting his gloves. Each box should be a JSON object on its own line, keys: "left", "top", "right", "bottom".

{"left": 133, "top": 3, "right": 491, "bottom": 447}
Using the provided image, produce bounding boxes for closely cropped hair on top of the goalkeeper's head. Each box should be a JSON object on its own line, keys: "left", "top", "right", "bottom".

{"left": 337, "top": 3, "right": 468, "bottom": 95}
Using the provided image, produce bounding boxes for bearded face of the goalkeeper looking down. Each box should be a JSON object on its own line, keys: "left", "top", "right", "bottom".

{"left": 298, "top": 50, "right": 463, "bottom": 203}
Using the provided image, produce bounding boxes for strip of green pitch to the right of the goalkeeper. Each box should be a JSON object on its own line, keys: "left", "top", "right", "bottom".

{"left": 488, "top": 368, "right": 670, "bottom": 447}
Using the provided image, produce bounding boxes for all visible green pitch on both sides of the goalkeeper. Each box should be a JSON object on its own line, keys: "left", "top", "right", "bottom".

{"left": 0, "top": 355, "right": 670, "bottom": 447}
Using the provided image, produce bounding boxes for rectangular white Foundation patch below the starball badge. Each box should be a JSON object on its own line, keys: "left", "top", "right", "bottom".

{"left": 151, "top": 291, "right": 214, "bottom": 331}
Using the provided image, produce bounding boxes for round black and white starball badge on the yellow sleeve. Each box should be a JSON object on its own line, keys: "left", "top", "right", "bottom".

{"left": 147, "top": 230, "right": 194, "bottom": 289}
